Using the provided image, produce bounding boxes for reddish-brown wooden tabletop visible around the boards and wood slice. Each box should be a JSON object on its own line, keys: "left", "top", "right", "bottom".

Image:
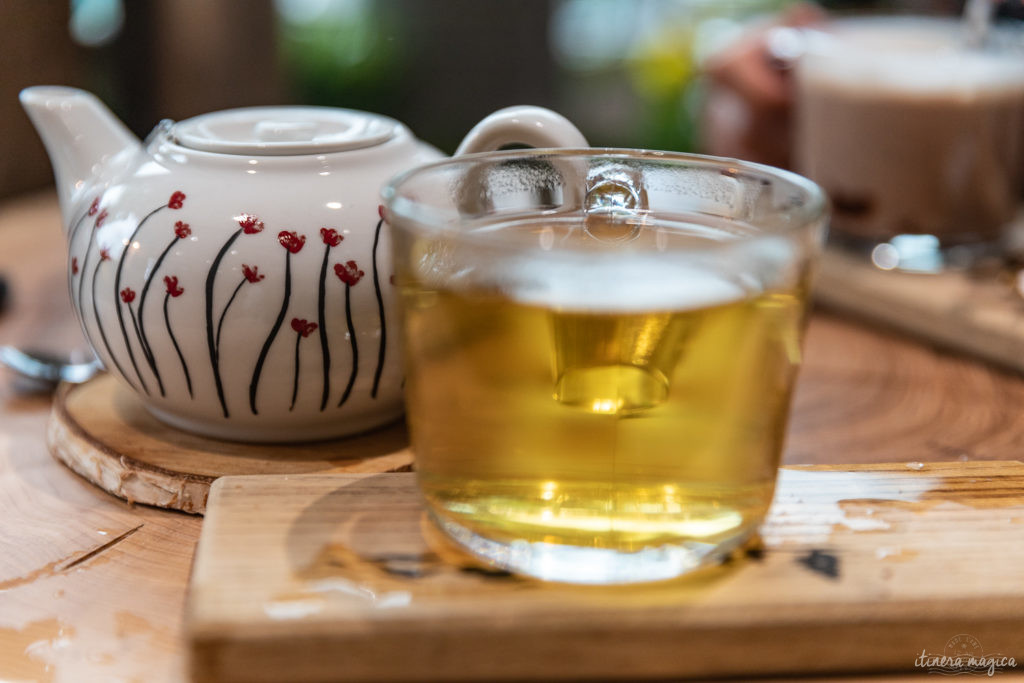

{"left": 0, "top": 188, "right": 1024, "bottom": 682}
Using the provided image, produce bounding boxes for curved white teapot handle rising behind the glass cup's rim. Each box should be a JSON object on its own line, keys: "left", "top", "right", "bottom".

{"left": 455, "top": 105, "right": 590, "bottom": 157}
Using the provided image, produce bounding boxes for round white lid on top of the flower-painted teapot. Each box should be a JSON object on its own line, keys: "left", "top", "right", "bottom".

{"left": 169, "top": 106, "right": 400, "bottom": 156}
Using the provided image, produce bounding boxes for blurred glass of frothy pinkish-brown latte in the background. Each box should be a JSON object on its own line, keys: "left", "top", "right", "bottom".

{"left": 795, "top": 17, "right": 1024, "bottom": 262}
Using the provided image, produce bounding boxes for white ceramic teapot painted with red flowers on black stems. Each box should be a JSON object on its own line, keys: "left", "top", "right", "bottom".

{"left": 20, "top": 86, "right": 587, "bottom": 441}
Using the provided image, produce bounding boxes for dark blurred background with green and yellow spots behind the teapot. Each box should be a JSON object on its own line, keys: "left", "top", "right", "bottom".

{"left": 0, "top": 0, "right": 1021, "bottom": 197}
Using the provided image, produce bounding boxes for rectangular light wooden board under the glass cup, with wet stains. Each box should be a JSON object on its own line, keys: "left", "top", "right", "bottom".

{"left": 186, "top": 462, "right": 1024, "bottom": 682}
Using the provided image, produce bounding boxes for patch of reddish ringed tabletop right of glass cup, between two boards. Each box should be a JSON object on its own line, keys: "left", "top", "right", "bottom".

{"left": 782, "top": 310, "right": 1024, "bottom": 464}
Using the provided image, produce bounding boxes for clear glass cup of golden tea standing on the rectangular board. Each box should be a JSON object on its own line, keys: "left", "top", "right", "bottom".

{"left": 384, "top": 150, "right": 826, "bottom": 584}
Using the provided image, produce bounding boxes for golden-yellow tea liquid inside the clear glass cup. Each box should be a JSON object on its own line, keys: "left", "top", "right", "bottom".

{"left": 401, "top": 222, "right": 805, "bottom": 556}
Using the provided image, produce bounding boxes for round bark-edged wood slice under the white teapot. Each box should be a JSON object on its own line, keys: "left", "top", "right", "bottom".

{"left": 46, "top": 375, "right": 413, "bottom": 514}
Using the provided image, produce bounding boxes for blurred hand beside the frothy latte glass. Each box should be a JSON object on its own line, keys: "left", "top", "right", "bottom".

{"left": 700, "top": 3, "right": 824, "bottom": 168}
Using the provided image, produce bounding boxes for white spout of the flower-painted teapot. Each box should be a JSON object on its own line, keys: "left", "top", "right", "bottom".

{"left": 20, "top": 85, "right": 141, "bottom": 216}
